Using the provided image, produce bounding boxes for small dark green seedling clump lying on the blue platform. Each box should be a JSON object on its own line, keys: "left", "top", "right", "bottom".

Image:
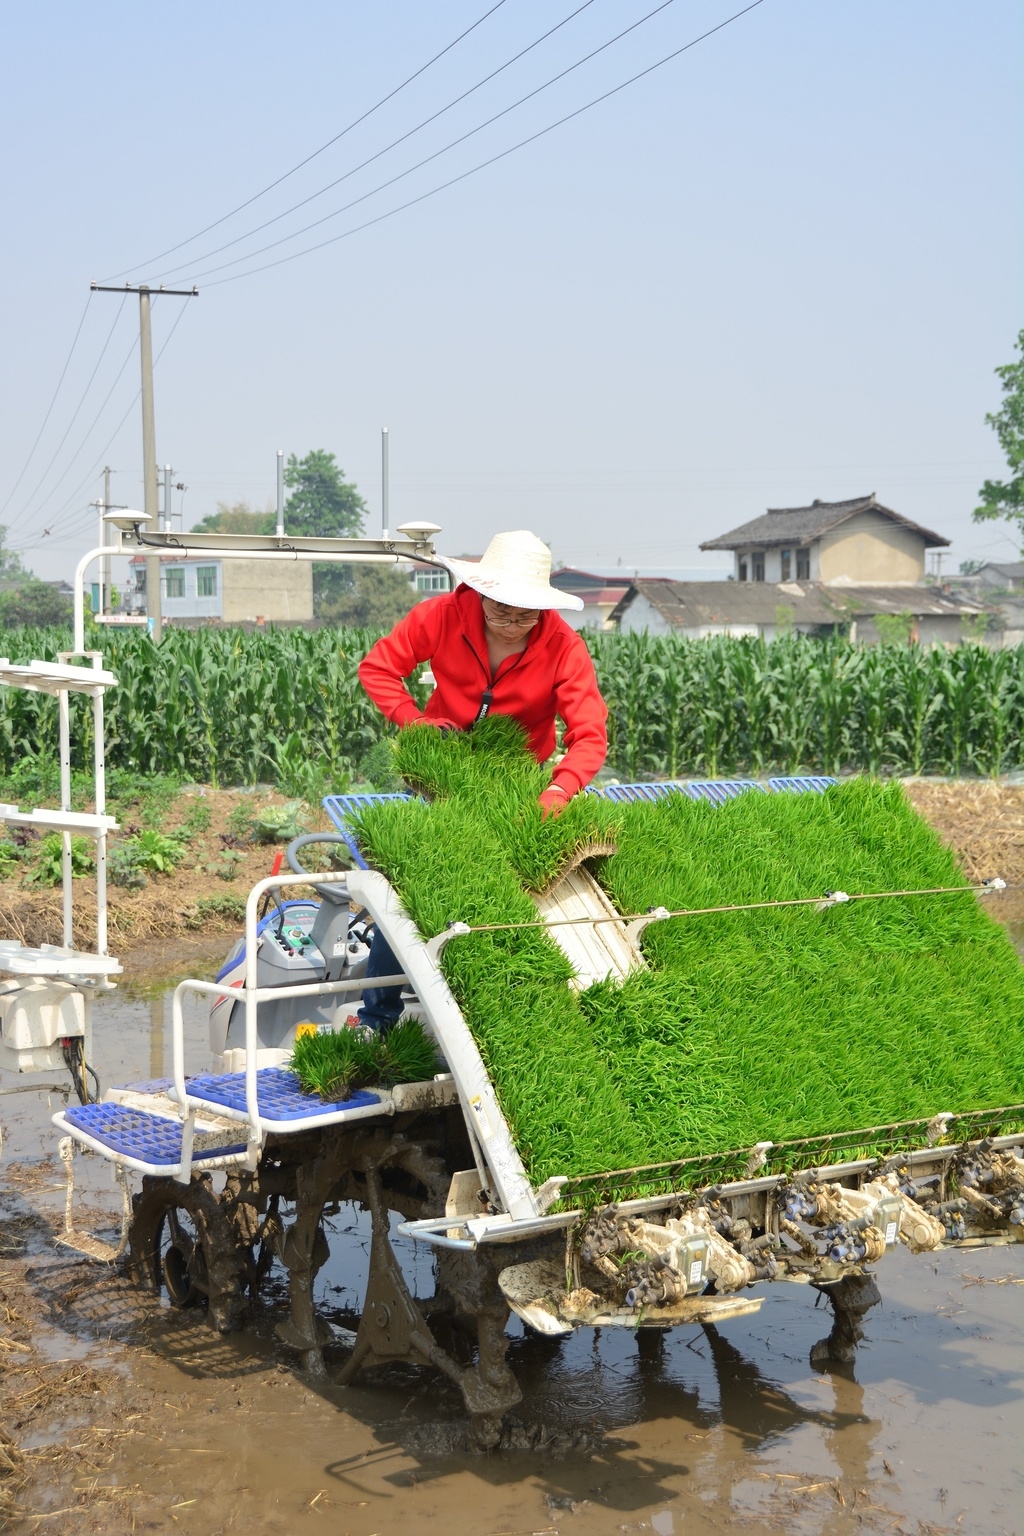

{"left": 289, "top": 1018, "right": 438, "bottom": 1101}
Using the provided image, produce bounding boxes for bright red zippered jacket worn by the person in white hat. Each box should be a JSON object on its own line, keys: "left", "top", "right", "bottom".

{"left": 359, "top": 584, "right": 608, "bottom": 796}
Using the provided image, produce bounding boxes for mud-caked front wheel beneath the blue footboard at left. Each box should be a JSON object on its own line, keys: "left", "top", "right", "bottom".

{"left": 127, "top": 1175, "right": 247, "bottom": 1333}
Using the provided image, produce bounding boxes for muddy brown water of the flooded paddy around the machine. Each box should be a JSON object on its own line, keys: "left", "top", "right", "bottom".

{"left": 0, "top": 970, "right": 1024, "bottom": 1536}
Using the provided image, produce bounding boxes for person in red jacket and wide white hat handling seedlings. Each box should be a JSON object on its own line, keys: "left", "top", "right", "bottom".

{"left": 359, "top": 531, "right": 608, "bottom": 1032}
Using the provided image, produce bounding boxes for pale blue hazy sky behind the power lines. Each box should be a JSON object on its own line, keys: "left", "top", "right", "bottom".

{"left": 0, "top": 0, "right": 1024, "bottom": 578}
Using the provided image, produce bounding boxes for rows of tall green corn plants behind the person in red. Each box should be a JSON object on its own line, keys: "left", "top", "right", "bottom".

{"left": 0, "top": 628, "right": 1024, "bottom": 788}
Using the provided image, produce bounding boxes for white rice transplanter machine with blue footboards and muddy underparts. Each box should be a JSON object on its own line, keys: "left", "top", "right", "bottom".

{"left": 11, "top": 513, "right": 1024, "bottom": 1444}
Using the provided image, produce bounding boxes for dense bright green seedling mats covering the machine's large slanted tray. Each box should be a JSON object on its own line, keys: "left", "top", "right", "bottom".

{"left": 350, "top": 716, "right": 1024, "bottom": 1183}
